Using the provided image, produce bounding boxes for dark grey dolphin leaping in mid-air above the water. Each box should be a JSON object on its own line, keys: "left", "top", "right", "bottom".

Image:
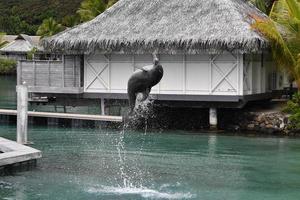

{"left": 127, "top": 55, "right": 164, "bottom": 113}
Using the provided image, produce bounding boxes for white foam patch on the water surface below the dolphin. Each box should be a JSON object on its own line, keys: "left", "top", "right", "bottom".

{"left": 87, "top": 186, "right": 195, "bottom": 199}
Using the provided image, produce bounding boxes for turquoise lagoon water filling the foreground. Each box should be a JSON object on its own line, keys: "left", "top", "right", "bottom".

{"left": 0, "top": 125, "right": 300, "bottom": 200}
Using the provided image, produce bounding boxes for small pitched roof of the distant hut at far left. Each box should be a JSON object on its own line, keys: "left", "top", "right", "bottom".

{"left": 0, "top": 34, "right": 42, "bottom": 53}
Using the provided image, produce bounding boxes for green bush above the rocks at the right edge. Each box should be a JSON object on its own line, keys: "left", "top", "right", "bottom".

{"left": 283, "top": 92, "right": 300, "bottom": 129}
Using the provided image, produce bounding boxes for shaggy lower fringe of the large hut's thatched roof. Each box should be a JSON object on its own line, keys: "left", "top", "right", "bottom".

{"left": 41, "top": 38, "right": 269, "bottom": 53}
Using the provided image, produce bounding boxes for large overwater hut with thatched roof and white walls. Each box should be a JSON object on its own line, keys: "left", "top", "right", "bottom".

{"left": 18, "top": 0, "right": 288, "bottom": 115}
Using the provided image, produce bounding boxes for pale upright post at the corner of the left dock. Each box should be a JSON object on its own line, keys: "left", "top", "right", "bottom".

{"left": 17, "top": 85, "right": 28, "bottom": 144}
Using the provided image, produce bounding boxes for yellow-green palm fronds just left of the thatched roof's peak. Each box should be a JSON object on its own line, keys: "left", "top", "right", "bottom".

{"left": 77, "top": 0, "right": 118, "bottom": 22}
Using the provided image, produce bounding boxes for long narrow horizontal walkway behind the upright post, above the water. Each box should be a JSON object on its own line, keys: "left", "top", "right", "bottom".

{"left": 0, "top": 109, "right": 123, "bottom": 122}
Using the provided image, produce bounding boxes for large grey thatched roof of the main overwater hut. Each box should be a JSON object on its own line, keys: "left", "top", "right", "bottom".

{"left": 43, "top": 0, "right": 267, "bottom": 53}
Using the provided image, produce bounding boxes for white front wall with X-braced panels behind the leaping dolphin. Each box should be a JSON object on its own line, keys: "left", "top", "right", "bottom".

{"left": 84, "top": 53, "right": 247, "bottom": 95}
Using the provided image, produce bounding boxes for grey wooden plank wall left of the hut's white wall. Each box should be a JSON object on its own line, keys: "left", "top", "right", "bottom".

{"left": 17, "top": 56, "right": 83, "bottom": 94}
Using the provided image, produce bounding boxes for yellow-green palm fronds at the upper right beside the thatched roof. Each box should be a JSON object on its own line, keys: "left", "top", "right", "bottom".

{"left": 252, "top": 0, "right": 300, "bottom": 89}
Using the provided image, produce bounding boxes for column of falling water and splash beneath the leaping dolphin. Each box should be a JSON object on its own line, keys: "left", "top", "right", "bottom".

{"left": 110, "top": 99, "right": 194, "bottom": 199}
